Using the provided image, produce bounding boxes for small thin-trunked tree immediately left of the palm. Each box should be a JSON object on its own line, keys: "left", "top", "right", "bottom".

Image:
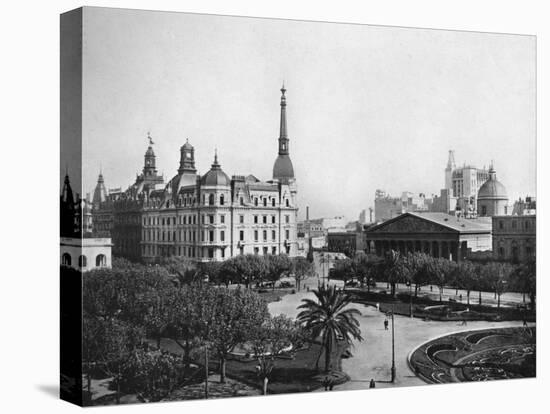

{"left": 251, "top": 315, "right": 300, "bottom": 395}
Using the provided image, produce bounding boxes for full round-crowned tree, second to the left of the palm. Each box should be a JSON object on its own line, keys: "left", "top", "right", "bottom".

{"left": 208, "top": 289, "right": 269, "bottom": 383}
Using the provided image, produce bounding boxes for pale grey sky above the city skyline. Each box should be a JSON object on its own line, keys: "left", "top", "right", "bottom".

{"left": 72, "top": 8, "right": 536, "bottom": 220}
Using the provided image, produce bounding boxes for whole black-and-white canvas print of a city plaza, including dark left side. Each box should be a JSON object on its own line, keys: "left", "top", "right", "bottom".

{"left": 59, "top": 7, "right": 537, "bottom": 406}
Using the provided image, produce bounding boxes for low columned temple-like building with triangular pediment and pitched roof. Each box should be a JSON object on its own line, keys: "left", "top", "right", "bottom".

{"left": 365, "top": 212, "right": 492, "bottom": 261}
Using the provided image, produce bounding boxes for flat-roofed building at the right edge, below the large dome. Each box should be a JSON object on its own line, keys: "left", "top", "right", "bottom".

{"left": 492, "top": 215, "right": 537, "bottom": 262}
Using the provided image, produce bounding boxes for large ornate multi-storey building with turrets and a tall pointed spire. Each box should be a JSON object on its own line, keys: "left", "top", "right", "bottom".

{"left": 94, "top": 86, "right": 298, "bottom": 263}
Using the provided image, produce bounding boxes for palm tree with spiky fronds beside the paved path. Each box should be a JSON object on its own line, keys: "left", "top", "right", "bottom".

{"left": 298, "top": 286, "right": 363, "bottom": 372}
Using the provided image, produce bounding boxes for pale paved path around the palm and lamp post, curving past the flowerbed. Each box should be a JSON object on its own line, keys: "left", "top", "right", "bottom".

{"left": 269, "top": 288, "right": 522, "bottom": 390}
